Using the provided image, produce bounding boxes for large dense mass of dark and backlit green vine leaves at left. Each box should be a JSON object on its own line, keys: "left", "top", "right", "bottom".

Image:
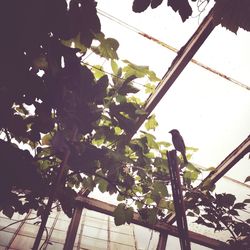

{"left": 0, "top": 0, "right": 249, "bottom": 248}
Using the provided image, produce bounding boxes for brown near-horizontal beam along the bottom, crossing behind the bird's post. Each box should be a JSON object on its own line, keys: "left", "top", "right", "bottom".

{"left": 76, "top": 196, "right": 227, "bottom": 250}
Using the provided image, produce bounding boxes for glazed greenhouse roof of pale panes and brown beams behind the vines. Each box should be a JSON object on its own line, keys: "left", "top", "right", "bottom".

{"left": 0, "top": 0, "right": 250, "bottom": 249}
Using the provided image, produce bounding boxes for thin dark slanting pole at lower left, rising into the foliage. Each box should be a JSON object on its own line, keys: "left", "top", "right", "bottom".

{"left": 32, "top": 127, "right": 78, "bottom": 250}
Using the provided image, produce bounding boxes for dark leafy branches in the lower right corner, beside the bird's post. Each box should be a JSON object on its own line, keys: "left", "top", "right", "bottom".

{"left": 186, "top": 191, "right": 250, "bottom": 249}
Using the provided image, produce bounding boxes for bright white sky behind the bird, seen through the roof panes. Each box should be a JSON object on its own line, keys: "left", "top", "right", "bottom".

{"left": 97, "top": 0, "right": 250, "bottom": 181}
